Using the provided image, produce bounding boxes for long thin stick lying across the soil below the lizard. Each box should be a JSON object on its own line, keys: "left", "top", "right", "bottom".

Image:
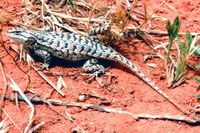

{"left": 0, "top": 95, "right": 200, "bottom": 124}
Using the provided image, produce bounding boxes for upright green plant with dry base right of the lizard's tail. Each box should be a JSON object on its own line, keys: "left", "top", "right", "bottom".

{"left": 165, "top": 17, "right": 195, "bottom": 86}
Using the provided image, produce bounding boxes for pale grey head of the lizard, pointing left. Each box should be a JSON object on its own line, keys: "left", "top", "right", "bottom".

{"left": 6, "top": 27, "right": 35, "bottom": 45}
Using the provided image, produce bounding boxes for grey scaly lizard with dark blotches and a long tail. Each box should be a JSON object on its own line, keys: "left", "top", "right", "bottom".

{"left": 6, "top": 27, "right": 188, "bottom": 114}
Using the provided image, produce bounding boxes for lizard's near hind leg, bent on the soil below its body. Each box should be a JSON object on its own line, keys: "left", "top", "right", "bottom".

{"left": 83, "top": 58, "right": 105, "bottom": 77}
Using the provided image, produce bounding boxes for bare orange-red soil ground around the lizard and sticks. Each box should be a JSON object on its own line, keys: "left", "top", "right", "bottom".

{"left": 0, "top": 0, "right": 200, "bottom": 133}
